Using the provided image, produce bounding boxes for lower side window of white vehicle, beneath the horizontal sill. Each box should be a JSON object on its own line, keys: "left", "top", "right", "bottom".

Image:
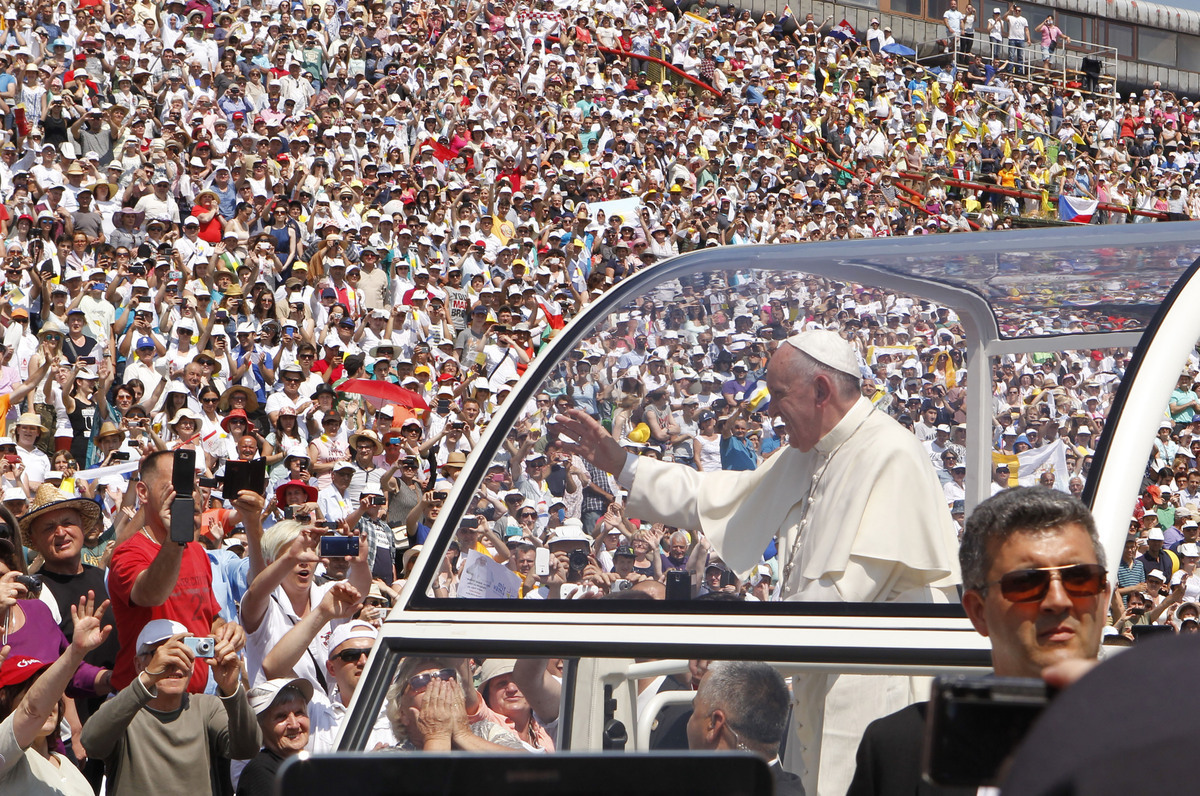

{"left": 338, "top": 656, "right": 945, "bottom": 794}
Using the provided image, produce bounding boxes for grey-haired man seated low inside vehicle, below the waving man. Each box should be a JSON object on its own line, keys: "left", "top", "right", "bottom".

{"left": 688, "top": 660, "right": 804, "bottom": 796}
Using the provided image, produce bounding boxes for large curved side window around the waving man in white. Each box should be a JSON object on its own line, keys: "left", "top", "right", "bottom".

{"left": 433, "top": 270, "right": 966, "bottom": 603}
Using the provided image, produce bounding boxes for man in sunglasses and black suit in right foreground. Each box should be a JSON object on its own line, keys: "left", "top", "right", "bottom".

{"left": 847, "top": 486, "right": 1110, "bottom": 796}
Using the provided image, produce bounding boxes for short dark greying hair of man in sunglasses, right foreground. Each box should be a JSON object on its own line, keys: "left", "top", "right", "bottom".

{"left": 959, "top": 486, "right": 1105, "bottom": 592}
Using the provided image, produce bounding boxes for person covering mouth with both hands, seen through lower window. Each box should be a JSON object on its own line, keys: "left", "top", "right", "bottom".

{"left": 388, "top": 657, "right": 526, "bottom": 753}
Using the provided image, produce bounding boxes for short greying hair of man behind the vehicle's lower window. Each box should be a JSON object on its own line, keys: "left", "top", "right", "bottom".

{"left": 704, "top": 660, "right": 792, "bottom": 747}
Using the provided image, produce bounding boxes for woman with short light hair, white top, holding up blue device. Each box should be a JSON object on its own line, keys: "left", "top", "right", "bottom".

{"left": 240, "top": 520, "right": 371, "bottom": 698}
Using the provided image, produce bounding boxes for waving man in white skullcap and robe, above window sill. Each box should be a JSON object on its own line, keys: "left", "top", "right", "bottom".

{"left": 558, "top": 330, "right": 961, "bottom": 603}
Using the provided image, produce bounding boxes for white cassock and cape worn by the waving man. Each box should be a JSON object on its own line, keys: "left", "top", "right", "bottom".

{"left": 619, "top": 397, "right": 962, "bottom": 796}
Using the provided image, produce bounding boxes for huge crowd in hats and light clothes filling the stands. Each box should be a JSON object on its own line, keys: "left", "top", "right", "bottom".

{"left": 0, "top": 0, "right": 1200, "bottom": 794}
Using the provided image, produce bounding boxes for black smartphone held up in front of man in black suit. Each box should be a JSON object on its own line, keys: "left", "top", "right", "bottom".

{"left": 922, "top": 675, "right": 1054, "bottom": 789}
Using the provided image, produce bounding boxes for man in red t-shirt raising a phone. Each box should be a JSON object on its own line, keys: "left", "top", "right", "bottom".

{"left": 108, "top": 450, "right": 254, "bottom": 694}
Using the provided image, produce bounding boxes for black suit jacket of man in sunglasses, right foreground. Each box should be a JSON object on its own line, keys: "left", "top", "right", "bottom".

{"left": 846, "top": 702, "right": 976, "bottom": 796}
